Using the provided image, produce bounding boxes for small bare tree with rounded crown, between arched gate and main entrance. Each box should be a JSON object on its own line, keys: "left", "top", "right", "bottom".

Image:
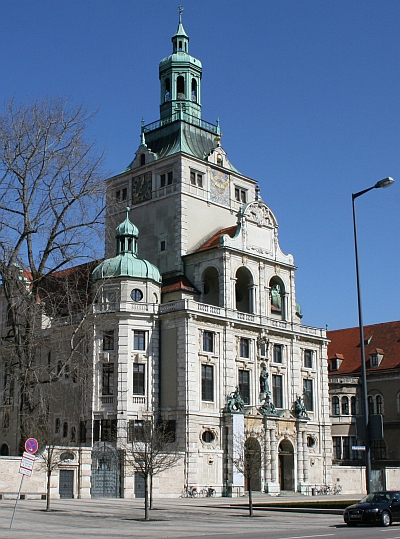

{"left": 125, "top": 418, "right": 182, "bottom": 520}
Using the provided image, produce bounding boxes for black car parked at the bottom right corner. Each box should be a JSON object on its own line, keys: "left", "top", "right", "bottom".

{"left": 343, "top": 490, "right": 400, "bottom": 526}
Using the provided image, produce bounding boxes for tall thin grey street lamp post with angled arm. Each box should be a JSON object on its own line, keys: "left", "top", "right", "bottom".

{"left": 351, "top": 177, "right": 394, "bottom": 494}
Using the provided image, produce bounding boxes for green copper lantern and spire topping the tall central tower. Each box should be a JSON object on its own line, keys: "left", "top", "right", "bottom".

{"left": 159, "top": 6, "right": 202, "bottom": 121}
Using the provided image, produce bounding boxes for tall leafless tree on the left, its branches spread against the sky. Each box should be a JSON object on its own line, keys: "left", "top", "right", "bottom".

{"left": 0, "top": 99, "right": 104, "bottom": 452}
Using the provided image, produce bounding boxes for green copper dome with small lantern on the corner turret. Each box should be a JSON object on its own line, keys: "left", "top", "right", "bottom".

{"left": 92, "top": 208, "right": 161, "bottom": 283}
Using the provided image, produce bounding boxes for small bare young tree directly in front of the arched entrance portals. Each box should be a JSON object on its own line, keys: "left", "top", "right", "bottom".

{"left": 232, "top": 433, "right": 262, "bottom": 517}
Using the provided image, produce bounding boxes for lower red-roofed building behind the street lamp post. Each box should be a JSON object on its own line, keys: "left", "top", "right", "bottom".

{"left": 328, "top": 321, "right": 400, "bottom": 489}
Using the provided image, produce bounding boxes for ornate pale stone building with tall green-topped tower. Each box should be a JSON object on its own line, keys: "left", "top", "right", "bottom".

{"left": 0, "top": 12, "right": 332, "bottom": 497}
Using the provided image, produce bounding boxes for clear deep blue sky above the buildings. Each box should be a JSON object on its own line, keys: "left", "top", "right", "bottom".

{"left": 0, "top": 0, "right": 400, "bottom": 329}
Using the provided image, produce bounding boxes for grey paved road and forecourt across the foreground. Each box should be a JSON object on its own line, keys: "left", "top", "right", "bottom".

{"left": 0, "top": 498, "right": 400, "bottom": 539}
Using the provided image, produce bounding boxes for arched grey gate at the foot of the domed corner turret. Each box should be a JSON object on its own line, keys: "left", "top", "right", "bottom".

{"left": 92, "top": 442, "right": 121, "bottom": 498}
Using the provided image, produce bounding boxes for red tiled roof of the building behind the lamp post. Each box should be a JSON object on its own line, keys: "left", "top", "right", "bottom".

{"left": 327, "top": 321, "right": 400, "bottom": 375}
